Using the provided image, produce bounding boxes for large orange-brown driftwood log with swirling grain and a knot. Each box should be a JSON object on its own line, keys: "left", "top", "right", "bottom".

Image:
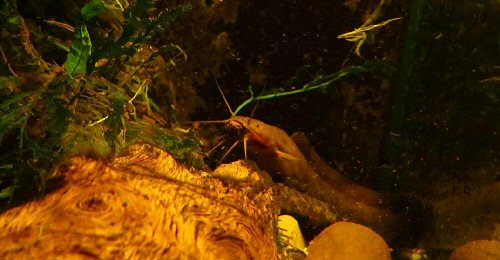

{"left": 0, "top": 145, "right": 278, "bottom": 259}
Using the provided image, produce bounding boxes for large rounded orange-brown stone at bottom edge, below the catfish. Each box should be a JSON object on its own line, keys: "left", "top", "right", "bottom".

{"left": 306, "top": 221, "right": 391, "bottom": 260}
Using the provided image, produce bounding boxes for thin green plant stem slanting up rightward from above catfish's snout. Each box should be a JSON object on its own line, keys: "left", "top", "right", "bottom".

{"left": 233, "top": 66, "right": 367, "bottom": 116}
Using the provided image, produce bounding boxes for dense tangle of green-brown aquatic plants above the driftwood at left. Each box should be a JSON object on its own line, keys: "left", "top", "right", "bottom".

{"left": 0, "top": 0, "right": 201, "bottom": 202}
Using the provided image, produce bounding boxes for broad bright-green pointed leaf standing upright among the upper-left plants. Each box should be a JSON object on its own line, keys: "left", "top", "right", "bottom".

{"left": 64, "top": 24, "right": 92, "bottom": 76}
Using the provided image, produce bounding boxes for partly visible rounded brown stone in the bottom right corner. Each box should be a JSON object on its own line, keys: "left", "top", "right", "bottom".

{"left": 449, "top": 240, "right": 500, "bottom": 260}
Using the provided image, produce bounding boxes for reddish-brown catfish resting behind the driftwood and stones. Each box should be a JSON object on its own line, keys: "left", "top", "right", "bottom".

{"left": 240, "top": 116, "right": 418, "bottom": 242}
